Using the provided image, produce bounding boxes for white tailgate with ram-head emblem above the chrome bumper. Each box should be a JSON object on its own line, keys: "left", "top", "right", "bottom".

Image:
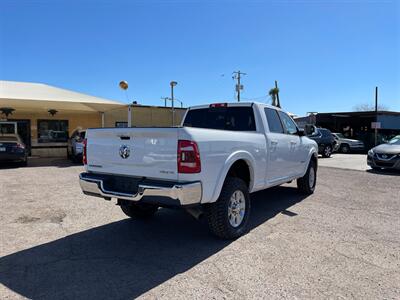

{"left": 86, "top": 128, "right": 179, "bottom": 180}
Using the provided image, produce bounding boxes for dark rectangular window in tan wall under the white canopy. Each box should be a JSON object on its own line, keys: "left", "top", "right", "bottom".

{"left": 38, "top": 120, "right": 68, "bottom": 143}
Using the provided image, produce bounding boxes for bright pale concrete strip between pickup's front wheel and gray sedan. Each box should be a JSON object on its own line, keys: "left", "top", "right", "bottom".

{"left": 319, "top": 153, "right": 371, "bottom": 171}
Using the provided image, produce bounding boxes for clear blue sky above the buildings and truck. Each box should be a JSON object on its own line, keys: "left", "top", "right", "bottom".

{"left": 0, "top": 0, "right": 400, "bottom": 115}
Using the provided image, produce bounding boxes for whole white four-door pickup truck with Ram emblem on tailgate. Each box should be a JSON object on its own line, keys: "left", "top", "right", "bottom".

{"left": 80, "top": 103, "right": 318, "bottom": 239}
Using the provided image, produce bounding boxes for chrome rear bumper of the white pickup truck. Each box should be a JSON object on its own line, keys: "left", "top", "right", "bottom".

{"left": 79, "top": 173, "right": 202, "bottom": 206}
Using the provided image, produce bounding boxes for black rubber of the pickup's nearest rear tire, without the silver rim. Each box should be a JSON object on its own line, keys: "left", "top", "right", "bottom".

{"left": 205, "top": 177, "right": 250, "bottom": 239}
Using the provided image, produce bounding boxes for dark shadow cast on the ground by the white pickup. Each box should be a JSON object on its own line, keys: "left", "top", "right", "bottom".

{"left": 0, "top": 186, "right": 305, "bottom": 299}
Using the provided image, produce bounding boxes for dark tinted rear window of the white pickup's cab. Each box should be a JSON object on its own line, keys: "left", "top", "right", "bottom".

{"left": 183, "top": 106, "right": 256, "bottom": 131}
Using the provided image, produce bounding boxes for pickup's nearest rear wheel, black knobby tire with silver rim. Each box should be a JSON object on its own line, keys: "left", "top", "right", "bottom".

{"left": 205, "top": 177, "right": 250, "bottom": 239}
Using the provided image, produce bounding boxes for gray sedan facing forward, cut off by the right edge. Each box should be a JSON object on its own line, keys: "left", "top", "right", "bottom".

{"left": 367, "top": 135, "right": 400, "bottom": 170}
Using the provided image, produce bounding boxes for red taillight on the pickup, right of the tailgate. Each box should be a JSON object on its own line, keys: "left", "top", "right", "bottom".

{"left": 178, "top": 140, "right": 201, "bottom": 173}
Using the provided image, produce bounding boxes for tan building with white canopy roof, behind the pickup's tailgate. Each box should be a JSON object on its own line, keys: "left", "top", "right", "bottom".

{"left": 0, "top": 81, "right": 186, "bottom": 157}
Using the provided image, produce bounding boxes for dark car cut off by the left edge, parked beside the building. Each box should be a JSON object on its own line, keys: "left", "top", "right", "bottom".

{"left": 0, "top": 134, "right": 28, "bottom": 166}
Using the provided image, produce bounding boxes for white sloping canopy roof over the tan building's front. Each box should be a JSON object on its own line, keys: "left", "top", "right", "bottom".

{"left": 0, "top": 81, "right": 126, "bottom": 112}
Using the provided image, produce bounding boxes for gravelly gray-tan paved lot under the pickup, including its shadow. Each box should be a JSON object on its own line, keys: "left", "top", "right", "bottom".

{"left": 0, "top": 160, "right": 400, "bottom": 299}
